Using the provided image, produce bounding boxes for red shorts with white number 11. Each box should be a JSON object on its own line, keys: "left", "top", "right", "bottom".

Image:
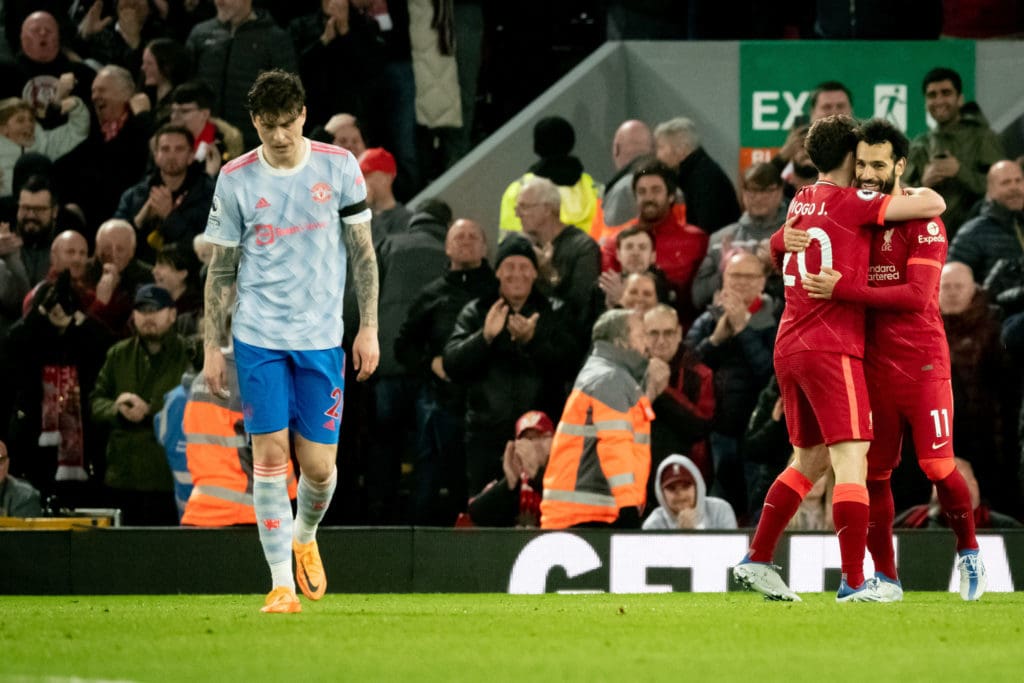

{"left": 867, "top": 375, "right": 953, "bottom": 478}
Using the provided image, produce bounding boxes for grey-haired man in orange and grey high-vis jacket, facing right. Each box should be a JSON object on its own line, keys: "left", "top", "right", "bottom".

{"left": 541, "top": 309, "right": 654, "bottom": 528}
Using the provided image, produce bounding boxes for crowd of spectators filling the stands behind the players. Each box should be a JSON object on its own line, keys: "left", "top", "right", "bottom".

{"left": 0, "top": 0, "right": 1024, "bottom": 529}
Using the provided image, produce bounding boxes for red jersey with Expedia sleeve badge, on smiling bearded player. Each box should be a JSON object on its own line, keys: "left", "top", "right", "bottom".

{"left": 865, "top": 218, "right": 949, "bottom": 381}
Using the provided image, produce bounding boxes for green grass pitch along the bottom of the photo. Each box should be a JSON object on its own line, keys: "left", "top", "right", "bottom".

{"left": 0, "top": 593, "right": 1024, "bottom": 683}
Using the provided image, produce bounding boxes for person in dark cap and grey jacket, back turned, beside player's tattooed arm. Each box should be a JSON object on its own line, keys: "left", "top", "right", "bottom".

{"left": 366, "top": 200, "right": 452, "bottom": 524}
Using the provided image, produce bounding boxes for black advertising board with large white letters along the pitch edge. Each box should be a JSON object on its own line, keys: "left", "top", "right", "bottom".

{"left": 0, "top": 527, "right": 1024, "bottom": 595}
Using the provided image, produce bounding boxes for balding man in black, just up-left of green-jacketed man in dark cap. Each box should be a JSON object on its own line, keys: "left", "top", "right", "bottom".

{"left": 86, "top": 218, "right": 153, "bottom": 338}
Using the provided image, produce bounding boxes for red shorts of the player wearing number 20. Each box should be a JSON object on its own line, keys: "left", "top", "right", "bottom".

{"left": 775, "top": 351, "right": 872, "bottom": 449}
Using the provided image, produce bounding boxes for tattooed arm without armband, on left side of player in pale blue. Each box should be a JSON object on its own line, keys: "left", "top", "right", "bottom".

{"left": 203, "top": 245, "right": 242, "bottom": 394}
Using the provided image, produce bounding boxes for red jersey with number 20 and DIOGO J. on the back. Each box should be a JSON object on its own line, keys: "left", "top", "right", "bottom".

{"left": 775, "top": 181, "right": 892, "bottom": 358}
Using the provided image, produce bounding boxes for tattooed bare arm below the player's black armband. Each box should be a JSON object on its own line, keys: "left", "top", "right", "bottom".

{"left": 343, "top": 221, "right": 381, "bottom": 382}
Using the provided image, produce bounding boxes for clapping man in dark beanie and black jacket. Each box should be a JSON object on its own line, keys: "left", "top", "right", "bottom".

{"left": 442, "top": 236, "right": 579, "bottom": 490}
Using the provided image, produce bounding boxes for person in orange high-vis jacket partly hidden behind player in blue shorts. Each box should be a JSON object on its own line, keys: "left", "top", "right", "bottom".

{"left": 181, "top": 353, "right": 296, "bottom": 526}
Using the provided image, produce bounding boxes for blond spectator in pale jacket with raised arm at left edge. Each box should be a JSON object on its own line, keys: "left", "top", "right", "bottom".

{"left": 0, "top": 96, "right": 89, "bottom": 196}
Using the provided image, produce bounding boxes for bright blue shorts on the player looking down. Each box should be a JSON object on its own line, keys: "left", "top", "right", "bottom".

{"left": 234, "top": 339, "right": 345, "bottom": 443}
